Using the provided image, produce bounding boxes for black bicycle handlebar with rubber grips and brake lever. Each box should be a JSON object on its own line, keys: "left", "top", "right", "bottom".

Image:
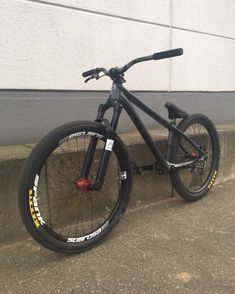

{"left": 82, "top": 48, "right": 183, "bottom": 81}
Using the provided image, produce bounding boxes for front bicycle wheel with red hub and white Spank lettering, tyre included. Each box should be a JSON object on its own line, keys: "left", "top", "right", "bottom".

{"left": 19, "top": 122, "right": 132, "bottom": 253}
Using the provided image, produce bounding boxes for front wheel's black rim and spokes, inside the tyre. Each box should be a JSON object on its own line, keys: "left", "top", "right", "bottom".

{"left": 28, "top": 132, "right": 123, "bottom": 242}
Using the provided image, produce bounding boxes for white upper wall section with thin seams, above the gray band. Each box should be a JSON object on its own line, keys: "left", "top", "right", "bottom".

{"left": 0, "top": 0, "right": 235, "bottom": 91}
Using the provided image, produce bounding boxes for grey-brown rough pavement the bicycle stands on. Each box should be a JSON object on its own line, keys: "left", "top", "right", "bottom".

{"left": 0, "top": 180, "right": 235, "bottom": 294}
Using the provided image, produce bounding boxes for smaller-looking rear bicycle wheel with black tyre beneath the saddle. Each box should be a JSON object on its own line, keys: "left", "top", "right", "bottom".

{"left": 170, "top": 114, "right": 220, "bottom": 201}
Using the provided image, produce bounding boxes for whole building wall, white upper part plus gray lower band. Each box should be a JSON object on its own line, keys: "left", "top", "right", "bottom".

{"left": 0, "top": 0, "right": 235, "bottom": 145}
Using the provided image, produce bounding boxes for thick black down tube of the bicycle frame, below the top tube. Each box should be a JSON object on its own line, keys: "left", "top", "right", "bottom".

{"left": 119, "top": 96, "right": 168, "bottom": 169}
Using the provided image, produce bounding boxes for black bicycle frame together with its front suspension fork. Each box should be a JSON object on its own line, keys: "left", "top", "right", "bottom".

{"left": 81, "top": 81, "right": 205, "bottom": 190}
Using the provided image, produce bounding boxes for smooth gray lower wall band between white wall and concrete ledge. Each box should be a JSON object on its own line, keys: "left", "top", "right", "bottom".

{"left": 0, "top": 91, "right": 235, "bottom": 145}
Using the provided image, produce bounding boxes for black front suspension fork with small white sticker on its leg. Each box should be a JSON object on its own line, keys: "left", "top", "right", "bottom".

{"left": 80, "top": 103, "right": 122, "bottom": 190}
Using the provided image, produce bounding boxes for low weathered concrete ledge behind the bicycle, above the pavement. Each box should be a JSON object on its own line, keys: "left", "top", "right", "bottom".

{"left": 0, "top": 123, "right": 235, "bottom": 245}
